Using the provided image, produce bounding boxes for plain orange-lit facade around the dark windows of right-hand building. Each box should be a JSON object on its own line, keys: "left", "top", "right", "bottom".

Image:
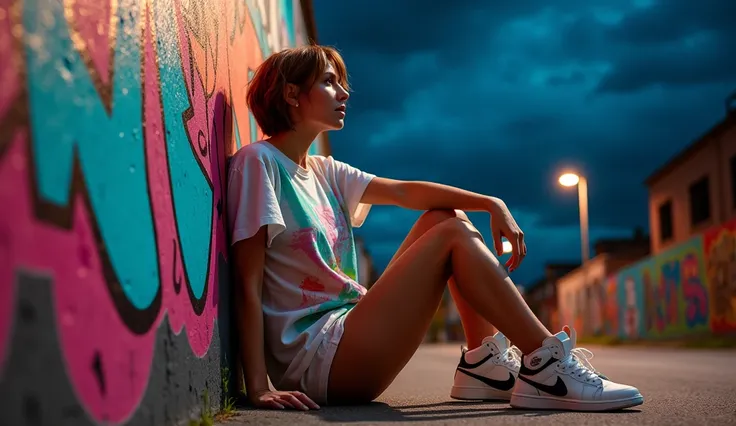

{"left": 649, "top": 118, "right": 736, "bottom": 254}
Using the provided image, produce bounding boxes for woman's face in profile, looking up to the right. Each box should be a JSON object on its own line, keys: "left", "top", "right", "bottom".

{"left": 297, "top": 64, "right": 350, "bottom": 131}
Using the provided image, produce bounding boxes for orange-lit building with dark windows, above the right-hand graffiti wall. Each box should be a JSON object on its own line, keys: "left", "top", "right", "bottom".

{"left": 646, "top": 93, "right": 736, "bottom": 255}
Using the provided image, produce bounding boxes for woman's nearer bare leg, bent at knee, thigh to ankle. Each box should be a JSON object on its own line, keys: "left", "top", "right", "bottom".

{"left": 328, "top": 218, "right": 551, "bottom": 404}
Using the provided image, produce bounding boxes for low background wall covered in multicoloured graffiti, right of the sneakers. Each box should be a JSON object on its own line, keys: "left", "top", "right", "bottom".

{"left": 562, "top": 231, "right": 729, "bottom": 339}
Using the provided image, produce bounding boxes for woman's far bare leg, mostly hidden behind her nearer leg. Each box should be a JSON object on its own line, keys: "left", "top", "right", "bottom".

{"left": 386, "top": 210, "right": 496, "bottom": 349}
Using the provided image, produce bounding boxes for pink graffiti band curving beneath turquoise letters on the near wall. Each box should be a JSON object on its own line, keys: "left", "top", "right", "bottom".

{"left": 0, "top": 3, "right": 226, "bottom": 423}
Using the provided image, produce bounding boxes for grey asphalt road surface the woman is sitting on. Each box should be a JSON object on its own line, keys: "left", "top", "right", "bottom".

{"left": 223, "top": 344, "right": 736, "bottom": 426}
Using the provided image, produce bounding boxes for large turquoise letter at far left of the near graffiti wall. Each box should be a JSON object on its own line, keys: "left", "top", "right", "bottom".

{"left": 23, "top": 0, "right": 161, "bottom": 333}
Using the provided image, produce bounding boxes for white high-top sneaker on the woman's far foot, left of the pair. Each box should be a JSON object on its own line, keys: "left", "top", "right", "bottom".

{"left": 450, "top": 332, "right": 521, "bottom": 401}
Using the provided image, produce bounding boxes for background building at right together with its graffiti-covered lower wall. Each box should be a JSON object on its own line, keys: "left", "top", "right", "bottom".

{"left": 557, "top": 92, "right": 736, "bottom": 339}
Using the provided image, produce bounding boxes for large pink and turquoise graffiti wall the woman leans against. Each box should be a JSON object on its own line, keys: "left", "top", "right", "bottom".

{"left": 0, "top": 0, "right": 316, "bottom": 425}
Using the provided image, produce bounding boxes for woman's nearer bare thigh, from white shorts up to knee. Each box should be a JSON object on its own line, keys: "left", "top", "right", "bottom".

{"left": 328, "top": 218, "right": 477, "bottom": 404}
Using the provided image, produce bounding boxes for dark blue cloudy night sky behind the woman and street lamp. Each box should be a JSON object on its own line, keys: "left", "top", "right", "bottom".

{"left": 314, "top": 0, "right": 736, "bottom": 285}
